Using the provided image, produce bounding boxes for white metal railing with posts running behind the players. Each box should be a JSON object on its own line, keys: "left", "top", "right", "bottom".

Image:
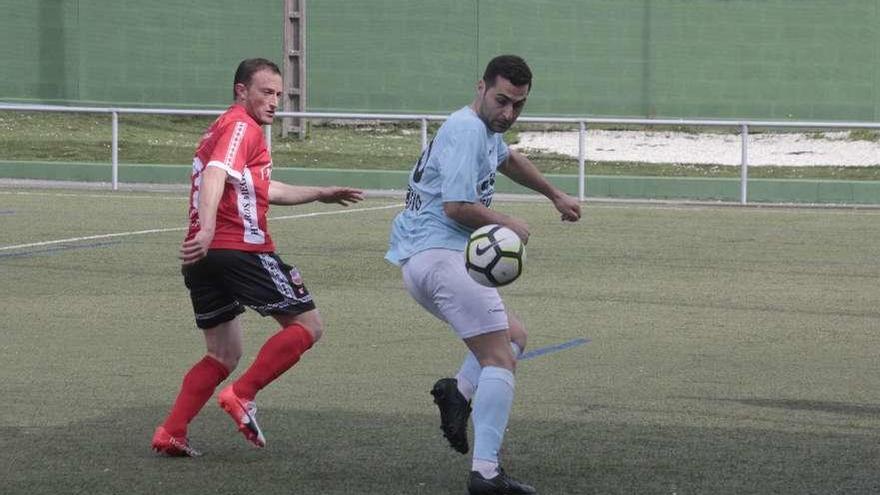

{"left": 0, "top": 102, "right": 880, "bottom": 204}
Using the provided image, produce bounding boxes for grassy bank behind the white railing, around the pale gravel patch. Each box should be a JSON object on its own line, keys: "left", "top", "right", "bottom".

{"left": 0, "top": 111, "right": 880, "bottom": 180}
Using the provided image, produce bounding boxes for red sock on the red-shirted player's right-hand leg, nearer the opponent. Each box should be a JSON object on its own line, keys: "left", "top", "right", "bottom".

{"left": 232, "top": 323, "right": 313, "bottom": 400}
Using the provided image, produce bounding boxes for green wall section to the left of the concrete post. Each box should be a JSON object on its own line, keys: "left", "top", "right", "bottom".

{"left": 0, "top": 0, "right": 283, "bottom": 107}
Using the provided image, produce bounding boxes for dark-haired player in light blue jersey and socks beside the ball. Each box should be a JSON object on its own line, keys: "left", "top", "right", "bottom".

{"left": 385, "top": 55, "right": 581, "bottom": 494}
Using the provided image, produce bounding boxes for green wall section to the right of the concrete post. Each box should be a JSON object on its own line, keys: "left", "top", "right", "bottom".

{"left": 308, "top": 0, "right": 880, "bottom": 121}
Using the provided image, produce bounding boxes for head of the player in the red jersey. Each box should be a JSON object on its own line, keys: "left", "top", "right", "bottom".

{"left": 232, "top": 58, "right": 282, "bottom": 125}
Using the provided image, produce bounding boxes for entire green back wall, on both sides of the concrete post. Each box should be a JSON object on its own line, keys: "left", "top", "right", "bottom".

{"left": 0, "top": 0, "right": 880, "bottom": 121}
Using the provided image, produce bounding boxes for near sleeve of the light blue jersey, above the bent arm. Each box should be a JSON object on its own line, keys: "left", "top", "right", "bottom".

{"left": 438, "top": 130, "right": 483, "bottom": 203}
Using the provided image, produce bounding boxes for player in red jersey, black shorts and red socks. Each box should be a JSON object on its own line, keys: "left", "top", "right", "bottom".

{"left": 152, "top": 58, "right": 363, "bottom": 456}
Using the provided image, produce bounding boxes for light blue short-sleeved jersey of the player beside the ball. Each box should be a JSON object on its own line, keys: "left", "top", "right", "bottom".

{"left": 385, "top": 107, "right": 508, "bottom": 265}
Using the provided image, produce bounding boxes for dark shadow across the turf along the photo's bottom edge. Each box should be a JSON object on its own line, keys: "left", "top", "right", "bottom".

{"left": 0, "top": 405, "right": 880, "bottom": 495}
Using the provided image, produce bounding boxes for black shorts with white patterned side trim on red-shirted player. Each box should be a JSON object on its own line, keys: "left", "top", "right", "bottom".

{"left": 181, "top": 249, "right": 315, "bottom": 329}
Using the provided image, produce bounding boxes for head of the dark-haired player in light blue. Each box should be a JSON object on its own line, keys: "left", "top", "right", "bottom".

{"left": 471, "top": 55, "right": 532, "bottom": 132}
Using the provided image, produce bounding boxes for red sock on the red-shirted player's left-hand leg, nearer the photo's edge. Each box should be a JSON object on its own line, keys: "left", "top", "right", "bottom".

{"left": 162, "top": 356, "right": 229, "bottom": 437}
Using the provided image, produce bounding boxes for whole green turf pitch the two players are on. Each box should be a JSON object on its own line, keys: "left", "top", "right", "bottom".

{"left": 0, "top": 188, "right": 880, "bottom": 495}
